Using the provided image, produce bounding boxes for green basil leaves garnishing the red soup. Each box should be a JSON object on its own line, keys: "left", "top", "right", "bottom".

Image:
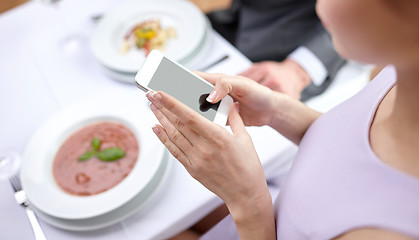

{"left": 78, "top": 138, "right": 125, "bottom": 162}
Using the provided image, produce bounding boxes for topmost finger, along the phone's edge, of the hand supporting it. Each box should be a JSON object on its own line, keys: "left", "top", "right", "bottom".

{"left": 147, "top": 91, "right": 220, "bottom": 139}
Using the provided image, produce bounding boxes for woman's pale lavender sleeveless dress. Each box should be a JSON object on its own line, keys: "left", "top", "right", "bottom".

{"left": 202, "top": 66, "right": 419, "bottom": 240}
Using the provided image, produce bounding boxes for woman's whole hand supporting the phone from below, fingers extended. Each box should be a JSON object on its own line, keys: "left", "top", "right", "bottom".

{"left": 147, "top": 92, "right": 275, "bottom": 238}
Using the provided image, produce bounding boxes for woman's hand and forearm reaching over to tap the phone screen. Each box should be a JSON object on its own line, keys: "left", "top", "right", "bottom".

{"left": 196, "top": 72, "right": 321, "bottom": 144}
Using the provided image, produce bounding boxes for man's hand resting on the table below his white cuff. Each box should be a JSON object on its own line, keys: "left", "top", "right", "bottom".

{"left": 240, "top": 58, "right": 311, "bottom": 99}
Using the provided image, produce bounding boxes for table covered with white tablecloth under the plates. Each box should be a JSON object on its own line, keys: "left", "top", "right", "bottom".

{"left": 0, "top": 0, "right": 369, "bottom": 239}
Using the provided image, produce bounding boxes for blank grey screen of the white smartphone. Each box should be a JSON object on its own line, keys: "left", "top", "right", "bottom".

{"left": 148, "top": 57, "right": 219, "bottom": 121}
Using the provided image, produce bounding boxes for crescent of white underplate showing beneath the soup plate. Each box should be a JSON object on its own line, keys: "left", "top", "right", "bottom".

{"left": 30, "top": 151, "right": 172, "bottom": 231}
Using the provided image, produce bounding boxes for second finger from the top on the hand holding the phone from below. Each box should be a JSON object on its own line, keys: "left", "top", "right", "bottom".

{"left": 150, "top": 103, "right": 192, "bottom": 153}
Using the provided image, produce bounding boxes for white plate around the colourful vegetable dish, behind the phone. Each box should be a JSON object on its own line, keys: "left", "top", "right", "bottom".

{"left": 91, "top": 0, "right": 207, "bottom": 73}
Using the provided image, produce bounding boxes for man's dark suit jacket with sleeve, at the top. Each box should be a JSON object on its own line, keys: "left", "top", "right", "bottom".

{"left": 208, "top": 0, "right": 345, "bottom": 100}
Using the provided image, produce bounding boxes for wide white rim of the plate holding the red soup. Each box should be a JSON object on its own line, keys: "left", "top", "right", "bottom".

{"left": 21, "top": 94, "right": 164, "bottom": 219}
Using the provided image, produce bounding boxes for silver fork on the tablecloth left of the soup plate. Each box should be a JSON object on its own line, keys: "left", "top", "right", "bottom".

{"left": 9, "top": 174, "right": 46, "bottom": 240}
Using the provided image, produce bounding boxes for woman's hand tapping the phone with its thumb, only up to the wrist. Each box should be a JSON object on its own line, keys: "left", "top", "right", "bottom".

{"left": 195, "top": 72, "right": 275, "bottom": 126}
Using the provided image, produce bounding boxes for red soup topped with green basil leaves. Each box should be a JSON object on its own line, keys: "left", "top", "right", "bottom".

{"left": 52, "top": 122, "right": 139, "bottom": 196}
